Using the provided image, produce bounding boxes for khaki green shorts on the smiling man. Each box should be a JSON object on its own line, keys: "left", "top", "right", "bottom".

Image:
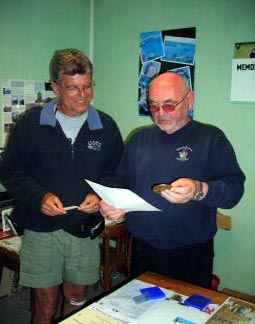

{"left": 19, "top": 230, "right": 100, "bottom": 288}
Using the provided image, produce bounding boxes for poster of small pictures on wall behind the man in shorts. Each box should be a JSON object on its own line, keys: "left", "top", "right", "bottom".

{"left": 2, "top": 80, "right": 55, "bottom": 143}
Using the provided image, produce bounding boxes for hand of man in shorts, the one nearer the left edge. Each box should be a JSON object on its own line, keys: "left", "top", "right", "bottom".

{"left": 41, "top": 192, "right": 66, "bottom": 216}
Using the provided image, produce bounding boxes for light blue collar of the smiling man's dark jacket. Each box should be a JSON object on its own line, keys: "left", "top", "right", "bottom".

{"left": 40, "top": 98, "right": 103, "bottom": 130}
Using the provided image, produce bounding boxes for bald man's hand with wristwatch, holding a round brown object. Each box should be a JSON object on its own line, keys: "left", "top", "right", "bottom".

{"left": 161, "top": 178, "right": 208, "bottom": 204}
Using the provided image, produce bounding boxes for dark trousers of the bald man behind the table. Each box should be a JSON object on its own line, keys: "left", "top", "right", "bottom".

{"left": 131, "top": 238, "right": 214, "bottom": 289}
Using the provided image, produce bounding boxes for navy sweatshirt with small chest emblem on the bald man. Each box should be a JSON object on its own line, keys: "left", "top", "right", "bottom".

{"left": 116, "top": 120, "right": 245, "bottom": 249}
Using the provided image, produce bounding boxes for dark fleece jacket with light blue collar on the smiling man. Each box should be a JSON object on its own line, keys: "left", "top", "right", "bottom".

{"left": 0, "top": 99, "right": 123, "bottom": 232}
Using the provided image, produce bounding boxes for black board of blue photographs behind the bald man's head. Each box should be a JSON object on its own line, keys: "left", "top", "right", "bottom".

{"left": 138, "top": 27, "right": 196, "bottom": 117}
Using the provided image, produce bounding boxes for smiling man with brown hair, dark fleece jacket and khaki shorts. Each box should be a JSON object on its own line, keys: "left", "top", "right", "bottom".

{"left": 0, "top": 49, "right": 123, "bottom": 324}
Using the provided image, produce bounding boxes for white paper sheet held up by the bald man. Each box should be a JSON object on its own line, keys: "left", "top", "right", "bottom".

{"left": 85, "top": 179, "right": 161, "bottom": 212}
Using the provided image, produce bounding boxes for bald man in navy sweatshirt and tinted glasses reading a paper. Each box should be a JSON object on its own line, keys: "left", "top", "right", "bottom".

{"left": 100, "top": 72, "right": 245, "bottom": 289}
